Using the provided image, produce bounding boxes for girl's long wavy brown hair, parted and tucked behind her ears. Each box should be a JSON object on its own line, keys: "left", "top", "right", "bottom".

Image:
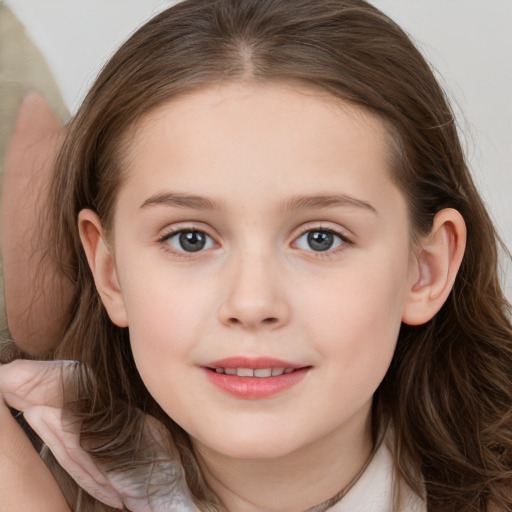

{"left": 51, "top": 0, "right": 512, "bottom": 512}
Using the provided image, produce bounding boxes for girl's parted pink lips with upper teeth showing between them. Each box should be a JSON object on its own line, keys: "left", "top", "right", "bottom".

{"left": 203, "top": 357, "right": 311, "bottom": 400}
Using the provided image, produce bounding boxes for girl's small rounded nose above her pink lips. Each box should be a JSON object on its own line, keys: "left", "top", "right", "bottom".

{"left": 219, "top": 250, "right": 290, "bottom": 330}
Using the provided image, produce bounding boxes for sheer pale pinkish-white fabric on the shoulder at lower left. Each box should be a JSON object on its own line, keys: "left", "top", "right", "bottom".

{"left": 0, "top": 360, "right": 199, "bottom": 512}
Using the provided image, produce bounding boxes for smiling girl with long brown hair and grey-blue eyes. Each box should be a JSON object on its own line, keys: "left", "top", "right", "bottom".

{"left": 3, "top": 0, "right": 512, "bottom": 512}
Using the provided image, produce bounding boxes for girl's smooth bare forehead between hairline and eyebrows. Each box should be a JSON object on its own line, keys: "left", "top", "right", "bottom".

{"left": 115, "top": 84, "right": 400, "bottom": 220}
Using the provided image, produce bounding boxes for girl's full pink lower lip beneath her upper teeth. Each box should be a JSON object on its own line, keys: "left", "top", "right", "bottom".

{"left": 204, "top": 367, "right": 310, "bottom": 400}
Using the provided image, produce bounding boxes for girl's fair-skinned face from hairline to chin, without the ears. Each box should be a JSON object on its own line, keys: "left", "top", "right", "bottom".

{"left": 98, "top": 84, "right": 418, "bottom": 458}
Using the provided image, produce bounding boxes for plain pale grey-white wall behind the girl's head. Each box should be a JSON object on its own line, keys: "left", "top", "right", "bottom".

{"left": 5, "top": 0, "right": 512, "bottom": 298}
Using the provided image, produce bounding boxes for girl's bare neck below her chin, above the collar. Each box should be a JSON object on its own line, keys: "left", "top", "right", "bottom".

{"left": 193, "top": 409, "right": 373, "bottom": 512}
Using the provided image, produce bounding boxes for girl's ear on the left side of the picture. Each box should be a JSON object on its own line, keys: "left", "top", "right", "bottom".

{"left": 78, "top": 210, "right": 128, "bottom": 327}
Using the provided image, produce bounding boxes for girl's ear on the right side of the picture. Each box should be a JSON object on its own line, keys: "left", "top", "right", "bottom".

{"left": 402, "top": 208, "right": 466, "bottom": 325}
